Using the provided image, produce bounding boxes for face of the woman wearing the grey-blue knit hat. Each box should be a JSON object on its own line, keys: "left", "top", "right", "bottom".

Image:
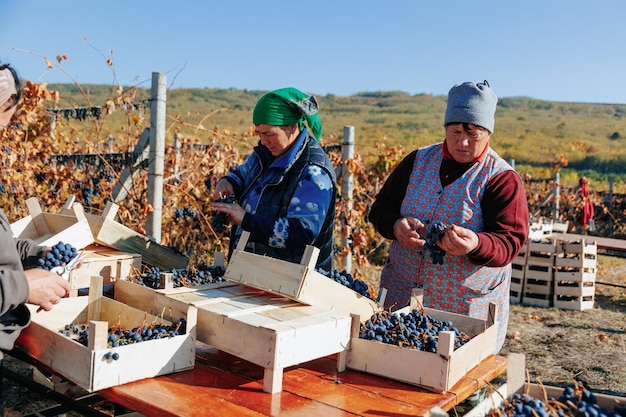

{"left": 446, "top": 123, "right": 491, "bottom": 162}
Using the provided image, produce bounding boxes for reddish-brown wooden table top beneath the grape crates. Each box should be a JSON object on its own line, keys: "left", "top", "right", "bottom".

{"left": 98, "top": 346, "right": 507, "bottom": 417}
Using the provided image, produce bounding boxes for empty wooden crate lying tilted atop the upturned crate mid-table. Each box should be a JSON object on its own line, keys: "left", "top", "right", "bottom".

{"left": 224, "top": 232, "right": 382, "bottom": 317}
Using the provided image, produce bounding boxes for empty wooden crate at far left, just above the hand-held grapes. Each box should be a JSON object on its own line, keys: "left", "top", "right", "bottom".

{"left": 11, "top": 197, "right": 94, "bottom": 249}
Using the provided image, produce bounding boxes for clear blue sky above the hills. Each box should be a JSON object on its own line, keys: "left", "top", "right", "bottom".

{"left": 0, "top": 0, "right": 626, "bottom": 103}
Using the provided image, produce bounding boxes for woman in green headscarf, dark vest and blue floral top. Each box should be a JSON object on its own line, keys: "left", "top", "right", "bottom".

{"left": 213, "top": 87, "right": 337, "bottom": 273}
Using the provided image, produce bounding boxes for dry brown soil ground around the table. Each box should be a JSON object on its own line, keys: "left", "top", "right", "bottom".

{"left": 2, "top": 255, "right": 626, "bottom": 417}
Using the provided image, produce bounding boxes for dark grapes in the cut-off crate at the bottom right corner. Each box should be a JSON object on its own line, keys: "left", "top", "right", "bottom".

{"left": 489, "top": 386, "right": 626, "bottom": 417}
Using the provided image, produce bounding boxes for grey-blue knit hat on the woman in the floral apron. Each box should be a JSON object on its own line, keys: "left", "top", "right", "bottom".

{"left": 444, "top": 80, "right": 498, "bottom": 133}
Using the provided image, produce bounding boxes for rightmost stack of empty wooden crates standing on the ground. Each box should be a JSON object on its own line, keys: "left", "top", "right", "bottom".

{"left": 553, "top": 239, "right": 598, "bottom": 310}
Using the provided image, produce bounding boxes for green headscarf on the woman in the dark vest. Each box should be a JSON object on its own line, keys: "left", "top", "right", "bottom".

{"left": 252, "top": 87, "right": 322, "bottom": 142}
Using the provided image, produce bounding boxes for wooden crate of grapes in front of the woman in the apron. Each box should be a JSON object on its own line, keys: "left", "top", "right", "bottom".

{"left": 346, "top": 291, "right": 498, "bottom": 392}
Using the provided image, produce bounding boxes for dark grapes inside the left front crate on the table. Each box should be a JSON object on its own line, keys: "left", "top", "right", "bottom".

{"left": 59, "top": 318, "right": 187, "bottom": 359}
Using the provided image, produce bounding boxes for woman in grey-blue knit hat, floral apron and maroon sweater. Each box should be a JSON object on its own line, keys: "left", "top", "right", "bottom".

{"left": 369, "top": 81, "right": 528, "bottom": 353}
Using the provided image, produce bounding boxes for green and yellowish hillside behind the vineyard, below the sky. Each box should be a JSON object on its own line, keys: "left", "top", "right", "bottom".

{"left": 48, "top": 84, "right": 626, "bottom": 188}
